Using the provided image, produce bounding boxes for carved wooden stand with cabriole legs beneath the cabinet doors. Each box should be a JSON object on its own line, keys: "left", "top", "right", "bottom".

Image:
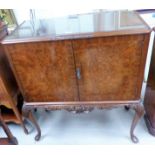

{"left": 22, "top": 101, "right": 144, "bottom": 143}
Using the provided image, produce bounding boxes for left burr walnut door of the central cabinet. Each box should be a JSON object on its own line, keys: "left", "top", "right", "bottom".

{"left": 5, "top": 41, "right": 78, "bottom": 102}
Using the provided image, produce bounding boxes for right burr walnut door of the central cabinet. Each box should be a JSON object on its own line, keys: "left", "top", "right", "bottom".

{"left": 73, "top": 35, "right": 145, "bottom": 101}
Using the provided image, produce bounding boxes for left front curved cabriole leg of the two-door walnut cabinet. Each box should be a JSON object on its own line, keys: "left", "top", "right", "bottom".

{"left": 22, "top": 105, "right": 41, "bottom": 141}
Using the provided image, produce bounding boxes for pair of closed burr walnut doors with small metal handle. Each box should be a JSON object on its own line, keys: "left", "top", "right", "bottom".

{"left": 5, "top": 34, "right": 145, "bottom": 102}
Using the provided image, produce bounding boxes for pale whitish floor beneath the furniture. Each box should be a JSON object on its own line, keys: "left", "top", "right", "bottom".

{"left": 0, "top": 108, "right": 155, "bottom": 145}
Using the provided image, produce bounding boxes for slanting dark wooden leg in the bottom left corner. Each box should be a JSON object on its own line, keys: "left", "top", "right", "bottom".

{"left": 0, "top": 113, "right": 18, "bottom": 145}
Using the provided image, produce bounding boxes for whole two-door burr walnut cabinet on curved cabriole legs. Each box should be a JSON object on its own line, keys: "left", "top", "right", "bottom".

{"left": 2, "top": 10, "right": 151, "bottom": 142}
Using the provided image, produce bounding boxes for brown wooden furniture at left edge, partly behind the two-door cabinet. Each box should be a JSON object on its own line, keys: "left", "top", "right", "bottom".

{"left": 0, "top": 24, "right": 27, "bottom": 132}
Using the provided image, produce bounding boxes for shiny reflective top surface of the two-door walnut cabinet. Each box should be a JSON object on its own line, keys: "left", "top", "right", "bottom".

{"left": 2, "top": 10, "right": 151, "bottom": 44}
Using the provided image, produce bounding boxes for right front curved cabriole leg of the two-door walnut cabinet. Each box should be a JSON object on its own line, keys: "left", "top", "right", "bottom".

{"left": 130, "top": 104, "right": 144, "bottom": 143}
